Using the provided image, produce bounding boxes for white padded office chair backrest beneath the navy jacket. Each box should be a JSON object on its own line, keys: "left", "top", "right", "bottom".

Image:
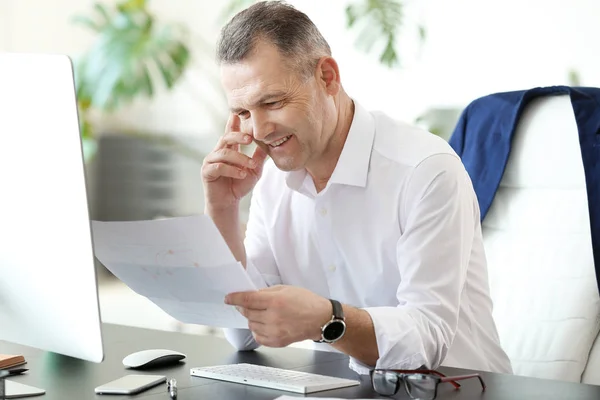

{"left": 482, "top": 95, "right": 600, "bottom": 382}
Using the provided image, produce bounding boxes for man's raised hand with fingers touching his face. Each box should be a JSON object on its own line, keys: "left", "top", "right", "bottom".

{"left": 202, "top": 114, "right": 267, "bottom": 210}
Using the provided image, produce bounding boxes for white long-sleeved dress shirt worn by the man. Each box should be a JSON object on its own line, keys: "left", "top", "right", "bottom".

{"left": 225, "top": 103, "right": 512, "bottom": 373}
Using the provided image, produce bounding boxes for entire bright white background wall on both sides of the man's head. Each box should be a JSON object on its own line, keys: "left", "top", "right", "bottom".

{"left": 0, "top": 0, "right": 600, "bottom": 137}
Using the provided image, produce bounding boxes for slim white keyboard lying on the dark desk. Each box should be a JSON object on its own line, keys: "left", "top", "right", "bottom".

{"left": 190, "top": 364, "right": 360, "bottom": 394}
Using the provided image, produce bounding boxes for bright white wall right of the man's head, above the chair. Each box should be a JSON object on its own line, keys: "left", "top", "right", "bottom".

{"left": 294, "top": 0, "right": 600, "bottom": 120}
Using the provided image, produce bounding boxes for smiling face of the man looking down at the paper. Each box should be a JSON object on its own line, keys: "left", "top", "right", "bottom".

{"left": 221, "top": 43, "right": 335, "bottom": 171}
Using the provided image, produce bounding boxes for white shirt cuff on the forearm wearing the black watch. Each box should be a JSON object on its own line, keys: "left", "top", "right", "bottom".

{"left": 360, "top": 307, "right": 435, "bottom": 372}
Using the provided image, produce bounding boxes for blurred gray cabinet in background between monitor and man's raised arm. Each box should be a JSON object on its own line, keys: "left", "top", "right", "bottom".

{"left": 92, "top": 134, "right": 204, "bottom": 221}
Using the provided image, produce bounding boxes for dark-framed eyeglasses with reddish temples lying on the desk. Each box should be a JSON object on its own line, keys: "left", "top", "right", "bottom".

{"left": 370, "top": 369, "right": 485, "bottom": 400}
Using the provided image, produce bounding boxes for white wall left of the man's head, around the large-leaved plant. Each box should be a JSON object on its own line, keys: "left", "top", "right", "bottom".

{"left": 0, "top": 0, "right": 227, "bottom": 141}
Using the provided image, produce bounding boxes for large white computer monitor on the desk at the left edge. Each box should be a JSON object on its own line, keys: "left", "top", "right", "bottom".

{"left": 0, "top": 53, "right": 104, "bottom": 362}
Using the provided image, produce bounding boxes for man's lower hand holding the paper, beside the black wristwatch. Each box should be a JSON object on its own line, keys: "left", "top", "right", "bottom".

{"left": 225, "top": 285, "right": 332, "bottom": 347}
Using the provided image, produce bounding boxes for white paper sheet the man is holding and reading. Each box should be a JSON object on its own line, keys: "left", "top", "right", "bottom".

{"left": 92, "top": 215, "right": 256, "bottom": 329}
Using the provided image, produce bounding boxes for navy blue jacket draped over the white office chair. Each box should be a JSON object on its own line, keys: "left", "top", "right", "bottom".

{"left": 449, "top": 86, "right": 600, "bottom": 289}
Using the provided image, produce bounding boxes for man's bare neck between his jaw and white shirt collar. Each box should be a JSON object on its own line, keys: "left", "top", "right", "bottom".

{"left": 307, "top": 93, "right": 354, "bottom": 193}
